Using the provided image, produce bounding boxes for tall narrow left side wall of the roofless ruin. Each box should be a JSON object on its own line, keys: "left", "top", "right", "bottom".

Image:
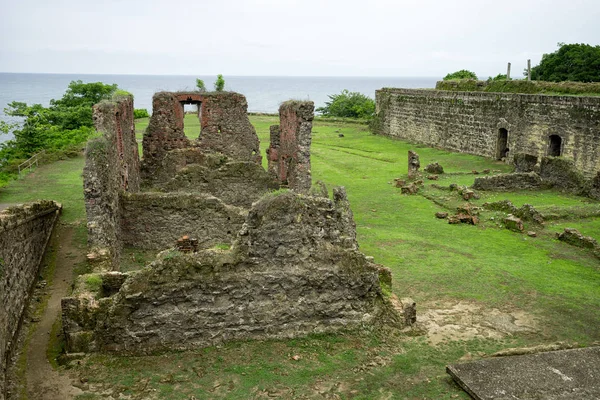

{"left": 83, "top": 96, "right": 140, "bottom": 270}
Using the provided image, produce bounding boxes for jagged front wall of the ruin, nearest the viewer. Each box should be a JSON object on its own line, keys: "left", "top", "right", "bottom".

{"left": 63, "top": 189, "right": 399, "bottom": 354}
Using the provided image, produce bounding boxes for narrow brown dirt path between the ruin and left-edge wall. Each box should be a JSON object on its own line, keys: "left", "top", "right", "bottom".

{"left": 27, "top": 223, "right": 82, "bottom": 400}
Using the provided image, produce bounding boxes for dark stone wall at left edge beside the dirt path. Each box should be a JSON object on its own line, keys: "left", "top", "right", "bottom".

{"left": 0, "top": 200, "right": 60, "bottom": 399}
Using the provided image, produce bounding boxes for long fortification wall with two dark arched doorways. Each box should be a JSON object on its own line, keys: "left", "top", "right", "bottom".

{"left": 374, "top": 88, "right": 600, "bottom": 178}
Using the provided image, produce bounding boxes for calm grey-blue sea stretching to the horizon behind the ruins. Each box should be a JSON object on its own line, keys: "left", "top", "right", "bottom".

{"left": 0, "top": 73, "right": 438, "bottom": 141}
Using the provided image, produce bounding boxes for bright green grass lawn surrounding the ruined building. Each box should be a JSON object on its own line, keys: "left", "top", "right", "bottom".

{"left": 0, "top": 115, "right": 600, "bottom": 399}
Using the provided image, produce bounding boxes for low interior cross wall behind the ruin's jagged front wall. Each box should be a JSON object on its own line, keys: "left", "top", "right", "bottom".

{"left": 120, "top": 192, "right": 247, "bottom": 250}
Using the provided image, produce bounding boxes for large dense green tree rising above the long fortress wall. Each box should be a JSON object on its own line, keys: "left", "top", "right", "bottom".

{"left": 531, "top": 43, "right": 600, "bottom": 82}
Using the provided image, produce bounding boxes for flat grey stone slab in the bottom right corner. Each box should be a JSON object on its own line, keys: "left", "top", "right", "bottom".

{"left": 446, "top": 347, "right": 600, "bottom": 400}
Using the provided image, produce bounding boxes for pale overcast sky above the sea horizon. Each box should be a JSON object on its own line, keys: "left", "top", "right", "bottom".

{"left": 0, "top": 0, "right": 600, "bottom": 77}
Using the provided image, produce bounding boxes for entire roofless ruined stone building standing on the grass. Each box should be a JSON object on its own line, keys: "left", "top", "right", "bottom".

{"left": 62, "top": 92, "right": 404, "bottom": 354}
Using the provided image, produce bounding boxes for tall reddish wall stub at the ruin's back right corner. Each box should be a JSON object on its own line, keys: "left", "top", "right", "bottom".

{"left": 267, "top": 100, "right": 315, "bottom": 193}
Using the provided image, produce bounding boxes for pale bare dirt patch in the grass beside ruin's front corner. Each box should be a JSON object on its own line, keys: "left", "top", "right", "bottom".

{"left": 417, "top": 301, "right": 538, "bottom": 345}
